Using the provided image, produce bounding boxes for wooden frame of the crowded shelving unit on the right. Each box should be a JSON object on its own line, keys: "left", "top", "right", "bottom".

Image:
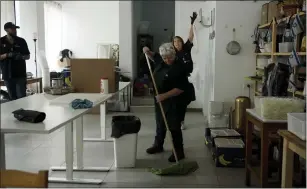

{"left": 250, "top": 12, "right": 306, "bottom": 98}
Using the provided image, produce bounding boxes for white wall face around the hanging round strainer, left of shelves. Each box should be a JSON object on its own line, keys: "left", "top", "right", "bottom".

{"left": 214, "top": 1, "right": 265, "bottom": 104}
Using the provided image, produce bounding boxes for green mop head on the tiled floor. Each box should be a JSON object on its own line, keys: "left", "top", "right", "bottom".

{"left": 149, "top": 161, "right": 199, "bottom": 176}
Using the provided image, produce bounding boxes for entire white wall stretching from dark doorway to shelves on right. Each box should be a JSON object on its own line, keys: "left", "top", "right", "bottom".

{"left": 175, "top": 1, "right": 265, "bottom": 112}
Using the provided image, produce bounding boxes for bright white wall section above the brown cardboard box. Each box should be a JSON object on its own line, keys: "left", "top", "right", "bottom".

{"left": 62, "top": 1, "right": 119, "bottom": 58}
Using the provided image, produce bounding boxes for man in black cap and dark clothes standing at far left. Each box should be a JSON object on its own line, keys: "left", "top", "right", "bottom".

{"left": 0, "top": 22, "right": 30, "bottom": 100}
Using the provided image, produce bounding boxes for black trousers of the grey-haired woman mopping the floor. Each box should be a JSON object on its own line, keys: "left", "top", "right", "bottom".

{"left": 155, "top": 103, "right": 183, "bottom": 151}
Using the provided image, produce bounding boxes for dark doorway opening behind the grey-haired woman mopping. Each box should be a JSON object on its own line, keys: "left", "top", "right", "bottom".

{"left": 132, "top": 0, "right": 175, "bottom": 96}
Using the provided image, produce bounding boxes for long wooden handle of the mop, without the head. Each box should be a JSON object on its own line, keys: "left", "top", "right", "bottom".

{"left": 145, "top": 53, "right": 179, "bottom": 163}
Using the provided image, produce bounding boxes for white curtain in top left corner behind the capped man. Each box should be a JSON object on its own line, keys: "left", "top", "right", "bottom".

{"left": 1, "top": 1, "right": 15, "bottom": 36}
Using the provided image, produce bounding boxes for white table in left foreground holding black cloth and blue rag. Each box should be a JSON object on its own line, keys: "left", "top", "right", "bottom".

{"left": 0, "top": 94, "right": 112, "bottom": 184}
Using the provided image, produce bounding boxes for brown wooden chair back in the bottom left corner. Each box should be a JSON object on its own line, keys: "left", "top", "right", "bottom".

{"left": 0, "top": 170, "right": 48, "bottom": 188}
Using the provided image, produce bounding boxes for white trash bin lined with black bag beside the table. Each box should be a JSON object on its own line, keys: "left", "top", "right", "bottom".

{"left": 111, "top": 116, "right": 141, "bottom": 168}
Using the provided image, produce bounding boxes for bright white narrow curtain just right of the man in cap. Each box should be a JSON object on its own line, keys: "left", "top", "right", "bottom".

{"left": 44, "top": 1, "right": 62, "bottom": 71}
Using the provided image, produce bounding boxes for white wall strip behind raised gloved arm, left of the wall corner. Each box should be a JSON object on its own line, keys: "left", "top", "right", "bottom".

{"left": 175, "top": 1, "right": 215, "bottom": 108}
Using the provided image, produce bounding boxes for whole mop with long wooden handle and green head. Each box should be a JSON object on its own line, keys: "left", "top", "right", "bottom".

{"left": 145, "top": 54, "right": 199, "bottom": 176}
